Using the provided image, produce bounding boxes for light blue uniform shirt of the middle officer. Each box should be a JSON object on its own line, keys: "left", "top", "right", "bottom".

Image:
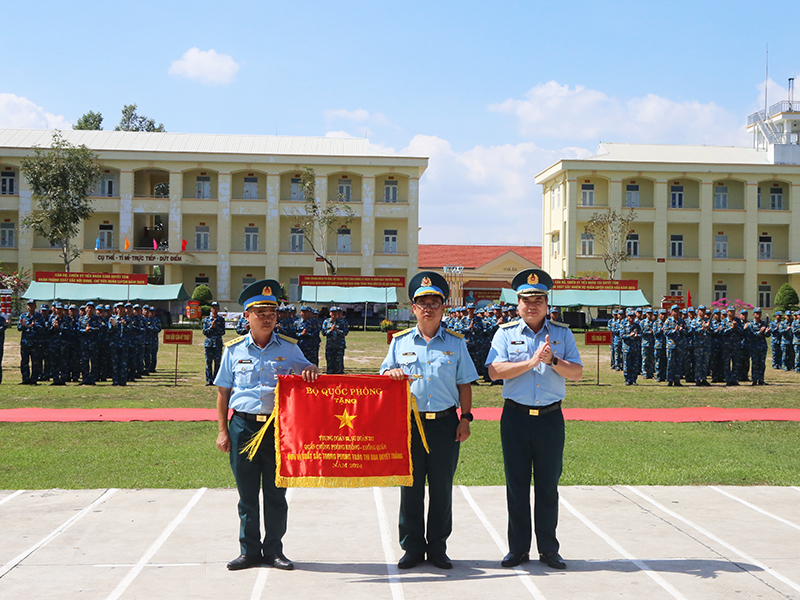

{"left": 381, "top": 326, "right": 478, "bottom": 412}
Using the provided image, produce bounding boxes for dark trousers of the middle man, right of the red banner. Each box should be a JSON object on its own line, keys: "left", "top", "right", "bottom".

{"left": 398, "top": 413, "right": 460, "bottom": 554}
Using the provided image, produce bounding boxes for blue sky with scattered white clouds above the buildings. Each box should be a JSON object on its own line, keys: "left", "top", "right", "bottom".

{"left": 0, "top": 0, "right": 797, "bottom": 244}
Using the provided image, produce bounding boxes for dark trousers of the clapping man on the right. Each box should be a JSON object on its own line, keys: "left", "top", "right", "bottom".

{"left": 500, "top": 406, "right": 564, "bottom": 553}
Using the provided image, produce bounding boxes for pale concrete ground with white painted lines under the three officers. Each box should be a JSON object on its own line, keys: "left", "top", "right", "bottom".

{"left": 0, "top": 486, "right": 800, "bottom": 600}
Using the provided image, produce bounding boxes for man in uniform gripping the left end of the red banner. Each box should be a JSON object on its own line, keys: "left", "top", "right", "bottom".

{"left": 219, "top": 279, "right": 319, "bottom": 571}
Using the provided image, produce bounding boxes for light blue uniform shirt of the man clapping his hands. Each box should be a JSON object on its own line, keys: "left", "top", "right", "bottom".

{"left": 486, "top": 319, "right": 583, "bottom": 406}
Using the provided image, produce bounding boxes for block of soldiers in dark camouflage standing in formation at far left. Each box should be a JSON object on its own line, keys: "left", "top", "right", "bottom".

{"left": 17, "top": 300, "right": 161, "bottom": 386}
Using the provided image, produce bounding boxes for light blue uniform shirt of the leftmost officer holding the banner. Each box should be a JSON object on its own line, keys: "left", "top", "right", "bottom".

{"left": 214, "top": 332, "right": 311, "bottom": 414}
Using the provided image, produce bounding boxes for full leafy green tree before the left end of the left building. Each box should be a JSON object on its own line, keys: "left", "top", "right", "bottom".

{"left": 21, "top": 131, "right": 103, "bottom": 272}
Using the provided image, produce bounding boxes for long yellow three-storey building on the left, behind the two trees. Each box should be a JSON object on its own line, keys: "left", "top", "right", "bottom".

{"left": 0, "top": 129, "right": 428, "bottom": 301}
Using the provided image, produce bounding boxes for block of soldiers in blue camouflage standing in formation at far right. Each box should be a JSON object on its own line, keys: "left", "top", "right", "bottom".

{"left": 608, "top": 305, "right": 788, "bottom": 386}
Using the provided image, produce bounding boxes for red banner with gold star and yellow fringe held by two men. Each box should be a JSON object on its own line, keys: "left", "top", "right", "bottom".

{"left": 275, "top": 375, "right": 413, "bottom": 487}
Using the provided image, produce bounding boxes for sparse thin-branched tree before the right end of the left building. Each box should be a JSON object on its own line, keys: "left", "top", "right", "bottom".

{"left": 286, "top": 167, "right": 356, "bottom": 275}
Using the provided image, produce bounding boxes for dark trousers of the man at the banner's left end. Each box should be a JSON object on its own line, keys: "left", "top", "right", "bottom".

{"left": 228, "top": 415, "right": 289, "bottom": 556}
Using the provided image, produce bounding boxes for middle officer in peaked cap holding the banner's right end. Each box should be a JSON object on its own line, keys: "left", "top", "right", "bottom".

{"left": 381, "top": 271, "right": 478, "bottom": 569}
